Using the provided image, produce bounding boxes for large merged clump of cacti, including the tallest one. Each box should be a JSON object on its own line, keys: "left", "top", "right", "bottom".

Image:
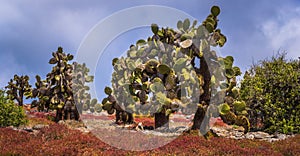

{"left": 102, "top": 6, "right": 249, "bottom": 131}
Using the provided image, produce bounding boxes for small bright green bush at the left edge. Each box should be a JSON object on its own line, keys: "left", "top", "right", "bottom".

{"left": 0, "top": 90, "right": 27, "bottom": 127}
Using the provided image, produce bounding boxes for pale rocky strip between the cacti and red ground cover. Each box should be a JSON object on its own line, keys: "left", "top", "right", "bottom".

{"left": 11, "top": 113, "right": 294, "bottom": 142}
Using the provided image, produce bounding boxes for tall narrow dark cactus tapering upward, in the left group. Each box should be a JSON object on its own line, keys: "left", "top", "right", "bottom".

{"left": 46, "top": 47, "right": 79, "bottom": 120}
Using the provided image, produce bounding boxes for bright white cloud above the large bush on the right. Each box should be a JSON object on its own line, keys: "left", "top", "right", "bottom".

{"left": 261, "top": 7, "right": 300, "bottom": 58}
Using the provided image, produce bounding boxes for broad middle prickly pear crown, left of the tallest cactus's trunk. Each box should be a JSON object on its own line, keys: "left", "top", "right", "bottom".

{"left": 103, "top": 21, "right": 209, "bottom": 127}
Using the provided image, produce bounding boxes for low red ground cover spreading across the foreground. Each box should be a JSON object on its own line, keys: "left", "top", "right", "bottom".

{"left": 0, "top": 118, "right": 300, "bottom": 156}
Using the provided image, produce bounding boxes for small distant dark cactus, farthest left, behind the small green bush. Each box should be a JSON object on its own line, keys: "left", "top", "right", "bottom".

{"left": 5, "top": 75, "right": 31, "bottom": 106}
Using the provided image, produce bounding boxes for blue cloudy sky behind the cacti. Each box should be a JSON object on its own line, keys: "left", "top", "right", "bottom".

{"left": 0, "top": 0, "right": 300, "bottom": 102}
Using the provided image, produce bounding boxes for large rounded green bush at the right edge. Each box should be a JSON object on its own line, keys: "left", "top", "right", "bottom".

{"left": 240, "top": 54, "right": 300, "bottom": 133}
